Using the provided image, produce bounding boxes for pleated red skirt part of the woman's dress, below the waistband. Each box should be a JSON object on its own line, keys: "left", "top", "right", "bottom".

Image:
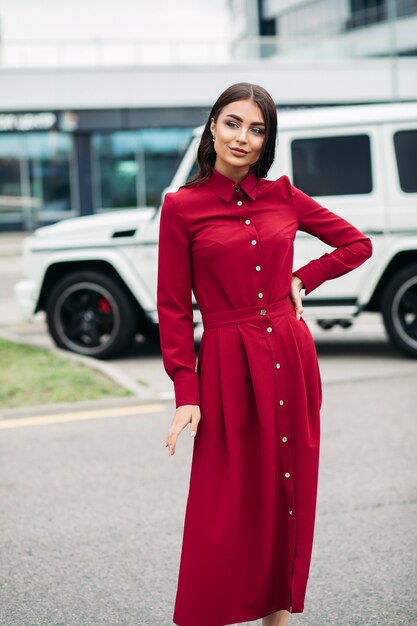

{"left": 173, "top": 298, "right": 322, "bottom": 626}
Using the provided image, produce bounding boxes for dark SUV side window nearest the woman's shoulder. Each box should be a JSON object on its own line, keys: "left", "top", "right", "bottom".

{"left": 291, "top": 135, "right": 372, "bottom": 196}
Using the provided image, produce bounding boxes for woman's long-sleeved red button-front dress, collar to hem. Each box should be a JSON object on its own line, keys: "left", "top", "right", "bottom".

{"left": 157, "top": 170, "right": 372, "bottom": 626}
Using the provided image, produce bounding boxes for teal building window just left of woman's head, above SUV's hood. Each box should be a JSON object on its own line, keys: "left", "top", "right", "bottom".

{"left": 92, "top": 128, "right": 193, "bottom": 211}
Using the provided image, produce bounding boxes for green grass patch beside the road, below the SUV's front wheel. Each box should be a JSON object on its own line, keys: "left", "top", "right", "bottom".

{"left": 0, "top": 339, "right": 132, "bottom": 409}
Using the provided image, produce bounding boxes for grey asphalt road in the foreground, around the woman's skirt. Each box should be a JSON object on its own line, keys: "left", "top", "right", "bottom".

{"left": 0, "top": 368, "right": 417, "bottom": 626}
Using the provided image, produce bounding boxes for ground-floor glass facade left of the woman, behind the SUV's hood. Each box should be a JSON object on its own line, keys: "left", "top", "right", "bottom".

{"left": 0, "top": 110, "right": 198, "bottom": 230}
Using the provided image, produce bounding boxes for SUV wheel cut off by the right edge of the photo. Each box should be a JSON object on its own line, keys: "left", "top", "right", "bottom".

{"left": 381, "top": 264, "right": 417, "bottom": 358}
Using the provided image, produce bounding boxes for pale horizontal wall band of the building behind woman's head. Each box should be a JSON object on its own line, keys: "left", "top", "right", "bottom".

{"left": 0, "top": 58, "right": 417, "bottom": 111}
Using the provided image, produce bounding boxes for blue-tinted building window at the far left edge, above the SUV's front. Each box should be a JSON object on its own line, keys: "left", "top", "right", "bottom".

{"left": 0, "top": 131, "right": 78, "bottom": 229}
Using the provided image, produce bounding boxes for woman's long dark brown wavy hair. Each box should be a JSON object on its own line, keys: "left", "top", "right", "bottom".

{"left": 186, "top": 83, "right": 278, "bottom": 185}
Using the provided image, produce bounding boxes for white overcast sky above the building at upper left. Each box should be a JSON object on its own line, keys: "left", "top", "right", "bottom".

{"left": 0, "top": 0, "right": 234, "bottom": 40}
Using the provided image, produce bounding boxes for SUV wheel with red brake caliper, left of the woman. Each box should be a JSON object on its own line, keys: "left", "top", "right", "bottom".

{"left": 45, "top": 271, "right": 137, "bottom": 359}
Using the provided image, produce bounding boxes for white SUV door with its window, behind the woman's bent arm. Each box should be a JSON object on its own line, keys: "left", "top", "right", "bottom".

{"left": 277, "top": 125, "right": 387, "bottom": 304}
